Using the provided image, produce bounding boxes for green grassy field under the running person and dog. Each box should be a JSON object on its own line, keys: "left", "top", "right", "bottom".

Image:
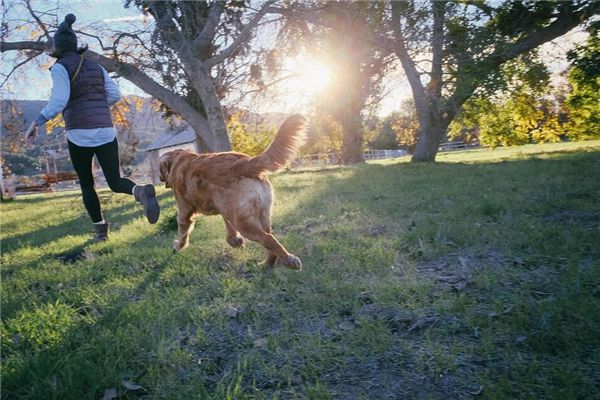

{"left": 1, "top": 141, "right": 600, "bottom": 400}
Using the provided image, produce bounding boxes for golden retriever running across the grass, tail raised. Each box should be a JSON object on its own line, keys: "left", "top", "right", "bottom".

{"left": 159, "top": 114, "right": 305, "bottom": 269}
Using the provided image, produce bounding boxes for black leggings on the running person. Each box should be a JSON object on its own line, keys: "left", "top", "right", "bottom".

{"left": 67, "top": 138, "right": 135, "bottom": 222}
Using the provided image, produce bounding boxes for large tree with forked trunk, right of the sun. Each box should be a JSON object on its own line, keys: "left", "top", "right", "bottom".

{"left": 381, "top": 0, "right": 600, "bottom": 161}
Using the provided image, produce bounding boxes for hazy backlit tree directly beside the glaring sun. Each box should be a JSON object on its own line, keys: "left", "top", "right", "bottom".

{"left": 313, "top": 1, "right": 389, "bottom": 164}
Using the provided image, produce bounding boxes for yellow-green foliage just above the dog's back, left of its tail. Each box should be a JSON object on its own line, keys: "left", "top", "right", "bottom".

{"left": 227, "top": 114, "right": 277, "bottom": 156}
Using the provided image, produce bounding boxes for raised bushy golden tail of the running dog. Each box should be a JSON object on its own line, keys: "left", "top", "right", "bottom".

{"left": 241, "top": 114, "right": 306, "bottom": 177}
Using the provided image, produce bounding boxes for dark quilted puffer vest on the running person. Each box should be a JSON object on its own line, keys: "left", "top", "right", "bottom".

{"left": 56, "top": 52, "right": 113, "bottom": 129}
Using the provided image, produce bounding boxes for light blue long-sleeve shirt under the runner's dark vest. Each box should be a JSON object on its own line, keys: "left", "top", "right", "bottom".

{"left": 36, "top": 64, "right": 121, "bottom": 147}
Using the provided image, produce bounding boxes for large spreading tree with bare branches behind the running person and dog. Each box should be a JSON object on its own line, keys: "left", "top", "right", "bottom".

{"left": 0, "top": 0, "right": 282, "bottom": 151}
